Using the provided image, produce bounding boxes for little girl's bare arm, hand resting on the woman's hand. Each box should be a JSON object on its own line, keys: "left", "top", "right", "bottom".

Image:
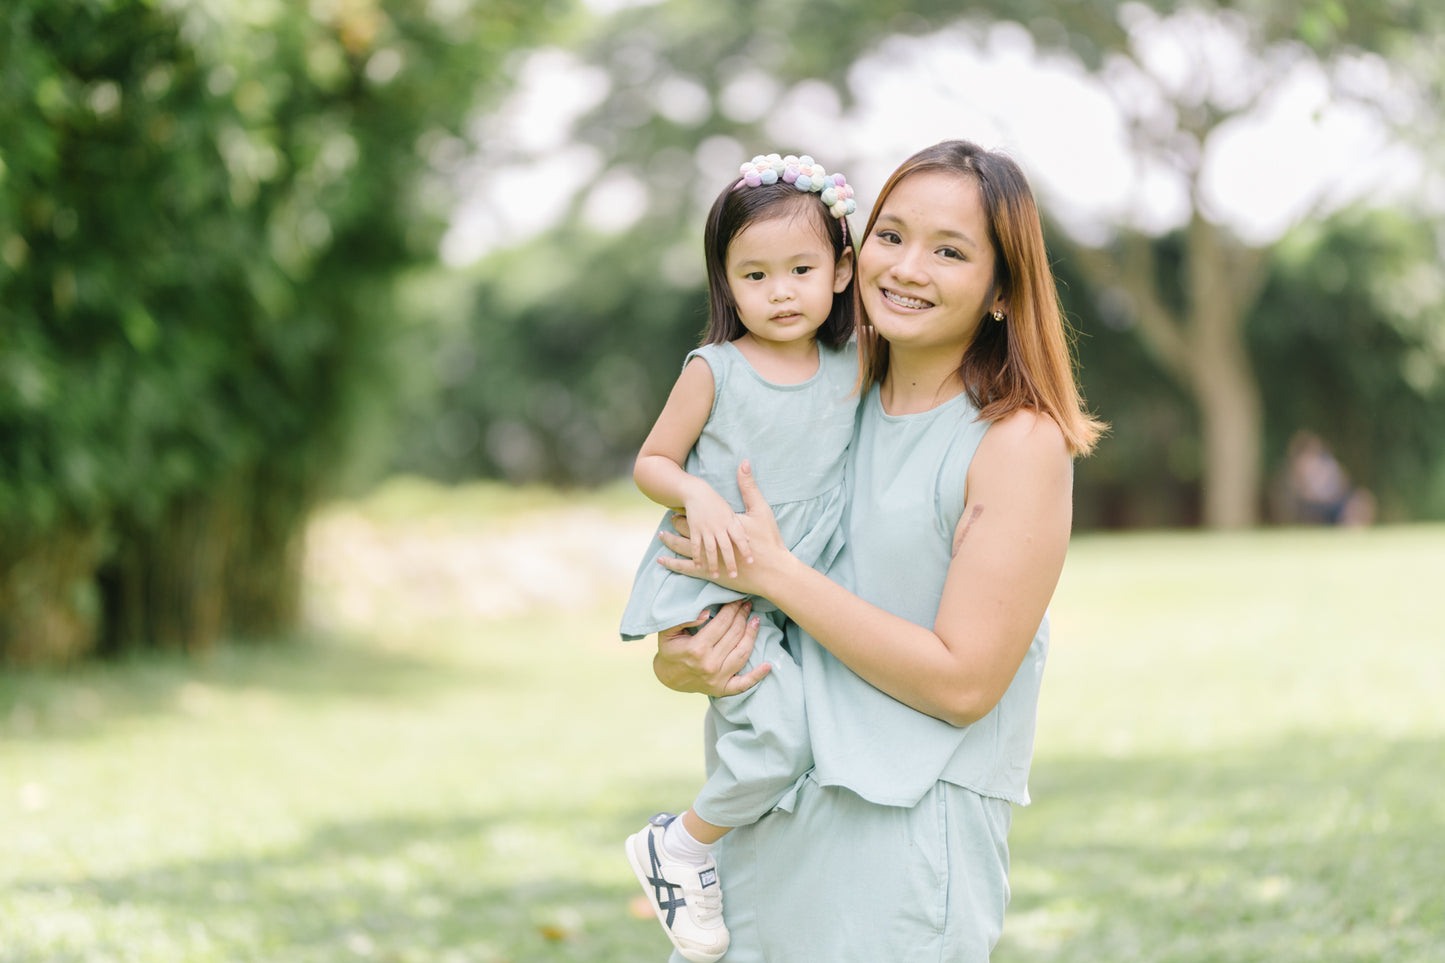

{"left": 633, "top": 357, "right": 747, "bottom": 577}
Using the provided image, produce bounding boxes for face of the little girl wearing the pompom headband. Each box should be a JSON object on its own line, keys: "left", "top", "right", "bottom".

{"left": 727, "top": 208, "right": 853, "bottom": 344}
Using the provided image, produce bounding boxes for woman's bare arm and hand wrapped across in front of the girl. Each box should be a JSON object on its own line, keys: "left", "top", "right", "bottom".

{"left": 656, "top": 411, "right": 1072, "bottom": 726}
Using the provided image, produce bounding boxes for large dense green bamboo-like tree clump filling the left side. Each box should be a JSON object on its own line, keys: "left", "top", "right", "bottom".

{"left": 0, "top": 0, "right": 568, "bottom": 662}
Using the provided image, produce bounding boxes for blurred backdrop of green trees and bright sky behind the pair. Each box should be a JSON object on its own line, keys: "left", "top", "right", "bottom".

{"left": 0, "top": 0, "right": 1445, "bottom": 661}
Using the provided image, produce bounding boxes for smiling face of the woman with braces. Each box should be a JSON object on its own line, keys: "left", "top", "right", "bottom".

{"left": 858, "top": 171, "right": 1006, "bottom": 357}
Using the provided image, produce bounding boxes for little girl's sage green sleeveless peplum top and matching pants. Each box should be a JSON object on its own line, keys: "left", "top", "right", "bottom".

{"left": 621, "top": 336, "right": 858, "bottom": 826}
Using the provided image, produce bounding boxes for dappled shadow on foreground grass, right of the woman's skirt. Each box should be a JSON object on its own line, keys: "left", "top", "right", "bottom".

{"left": 996, "top": 733, "right": 1445, "bottom": 963}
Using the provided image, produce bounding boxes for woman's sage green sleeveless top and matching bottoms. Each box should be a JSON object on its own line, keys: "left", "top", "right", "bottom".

{"left": 673, "top": 388, "right": 1049, "bottom": 963}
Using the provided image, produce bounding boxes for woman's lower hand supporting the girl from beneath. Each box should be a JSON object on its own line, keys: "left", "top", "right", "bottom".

{"left": 652, "top": 599, "right": 773, "bottom": 696}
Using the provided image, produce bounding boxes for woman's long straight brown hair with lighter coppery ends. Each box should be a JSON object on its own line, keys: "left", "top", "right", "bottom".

{"left": 858, "top": 140, "right": 1107, "bottom": 455}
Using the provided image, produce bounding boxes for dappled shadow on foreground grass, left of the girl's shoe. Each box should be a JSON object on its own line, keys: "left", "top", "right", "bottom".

{"left": 9, "top": 792, "right": 687, "bottom": 963}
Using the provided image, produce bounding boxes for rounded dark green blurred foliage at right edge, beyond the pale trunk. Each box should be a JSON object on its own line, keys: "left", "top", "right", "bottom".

{"left": 1250, "top": 202, "right": 1445, "bottom": 519}
